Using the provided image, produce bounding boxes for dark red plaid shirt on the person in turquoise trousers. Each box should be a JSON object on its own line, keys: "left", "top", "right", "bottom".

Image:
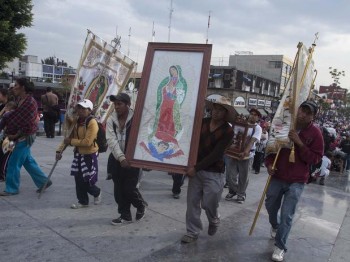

{"left": 6, "top": 95, "right": 38, "bottom": 136}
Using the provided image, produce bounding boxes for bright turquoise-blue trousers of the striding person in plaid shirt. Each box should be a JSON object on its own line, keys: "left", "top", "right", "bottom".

{"left": 5, "top": 140, "right": 47, "bottom": 194}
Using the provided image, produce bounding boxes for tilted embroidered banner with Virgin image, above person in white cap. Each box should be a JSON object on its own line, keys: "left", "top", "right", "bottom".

{"left": 66, "top": 31, "right": 135, "bottom": 129}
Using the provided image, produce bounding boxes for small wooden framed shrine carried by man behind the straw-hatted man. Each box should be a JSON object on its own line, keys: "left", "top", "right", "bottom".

{"left": 225, "top": 118, "right": 255, "bottom": 160}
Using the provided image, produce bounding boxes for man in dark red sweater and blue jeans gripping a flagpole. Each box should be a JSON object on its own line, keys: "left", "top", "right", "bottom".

{"left": 265, "top": 101, "right": 323, "bottom": 261}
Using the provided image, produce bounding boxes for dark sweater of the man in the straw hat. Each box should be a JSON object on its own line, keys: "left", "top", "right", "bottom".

{"left": 195, "top": 118, "right": 233, "bottom": 173}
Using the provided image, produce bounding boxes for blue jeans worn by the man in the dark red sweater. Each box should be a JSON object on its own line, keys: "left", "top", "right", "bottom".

{"left": 265, "top": 177, "right": 304, "bottom": 251}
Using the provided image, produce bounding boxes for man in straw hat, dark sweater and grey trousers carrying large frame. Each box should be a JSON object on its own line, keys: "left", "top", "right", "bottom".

{"left": 181, "top": 95, "right": 235, "bottom": 244}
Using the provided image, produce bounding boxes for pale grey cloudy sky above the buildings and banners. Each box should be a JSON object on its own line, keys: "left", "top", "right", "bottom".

{"left": 23, "top": 0, "right": 350, "bottom": 89}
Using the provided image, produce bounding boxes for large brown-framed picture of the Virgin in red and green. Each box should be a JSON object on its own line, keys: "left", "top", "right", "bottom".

{"left": 126, "top": 43, "right": 212, "bottom": 173}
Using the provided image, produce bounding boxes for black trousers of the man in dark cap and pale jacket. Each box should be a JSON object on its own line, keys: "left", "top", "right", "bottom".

{"left": 109, "top": 155, "right": 145, "bottom": 220}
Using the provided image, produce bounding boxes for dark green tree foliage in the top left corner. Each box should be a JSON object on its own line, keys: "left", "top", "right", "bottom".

{"left": 0, "top": 0, "right": 33, "bottom": 70}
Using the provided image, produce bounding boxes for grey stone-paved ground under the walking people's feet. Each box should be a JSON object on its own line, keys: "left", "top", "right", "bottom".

{"left": 0, "top": 137, "right": 350, "bottom": 262}
